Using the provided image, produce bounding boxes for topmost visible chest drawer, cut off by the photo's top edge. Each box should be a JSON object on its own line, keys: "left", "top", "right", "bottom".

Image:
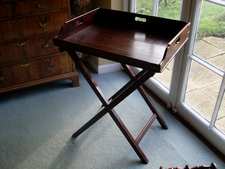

{"left": 14, "top": 0, "right": 68, "bottom": 16}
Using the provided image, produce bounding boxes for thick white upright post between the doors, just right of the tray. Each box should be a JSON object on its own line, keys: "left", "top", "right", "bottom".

{"left": 170, "top": 0, "right": 202, "bottom": 107}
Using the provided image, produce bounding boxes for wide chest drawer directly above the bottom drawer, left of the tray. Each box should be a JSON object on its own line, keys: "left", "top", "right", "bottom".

{"left": 0, "top": 33, "right": 59, "bottom": 66}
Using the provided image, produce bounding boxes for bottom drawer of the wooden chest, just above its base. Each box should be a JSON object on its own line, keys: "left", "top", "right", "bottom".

{"left": 0, "top": 53, "right": 74, "bottom": 88}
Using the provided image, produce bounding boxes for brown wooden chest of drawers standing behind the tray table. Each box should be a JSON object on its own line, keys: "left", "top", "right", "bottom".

{"left": 0, "top": 0, "right": 79, "bottom": 93}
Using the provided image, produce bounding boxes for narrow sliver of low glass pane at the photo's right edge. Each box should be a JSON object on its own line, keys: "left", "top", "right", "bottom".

{"left": 216, "top": 93, "right": 225, "bottom": 133}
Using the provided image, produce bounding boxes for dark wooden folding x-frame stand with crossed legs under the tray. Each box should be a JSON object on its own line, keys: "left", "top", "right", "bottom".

{"left": 68, "top": 51, "right": 168, "bottom": 164}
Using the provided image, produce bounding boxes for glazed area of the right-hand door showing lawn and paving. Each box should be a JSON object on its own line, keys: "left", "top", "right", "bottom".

{"left": 185, "top": 1, "right": 225, "bottom": 133}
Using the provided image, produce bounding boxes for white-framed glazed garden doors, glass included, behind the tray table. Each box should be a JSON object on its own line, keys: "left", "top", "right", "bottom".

{"left": 131, "top": 0, "right": 225, "bottom": 154}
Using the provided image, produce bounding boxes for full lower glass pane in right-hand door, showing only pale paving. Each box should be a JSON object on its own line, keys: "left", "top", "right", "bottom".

{"left": 185, "top": 61, "right": 222, "bottom": 121}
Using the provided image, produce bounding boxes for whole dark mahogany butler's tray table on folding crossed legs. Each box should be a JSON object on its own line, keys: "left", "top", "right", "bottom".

{"left": 54, "top": 8, "right": 190, "bottom": 163}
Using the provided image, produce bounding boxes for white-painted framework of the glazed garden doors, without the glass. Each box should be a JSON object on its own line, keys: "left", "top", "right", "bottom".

{"left": 127, "top": 0, "right": 225, "bottom": 154}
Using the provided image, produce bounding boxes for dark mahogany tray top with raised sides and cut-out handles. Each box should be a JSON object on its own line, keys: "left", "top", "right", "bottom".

{"left": 54, "top": 8, "right": 190, "bottom": 72}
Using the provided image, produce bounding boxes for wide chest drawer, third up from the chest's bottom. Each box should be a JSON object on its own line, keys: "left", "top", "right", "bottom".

{"left": 0, "top": 11, "right": 68, "bottom": 42}
